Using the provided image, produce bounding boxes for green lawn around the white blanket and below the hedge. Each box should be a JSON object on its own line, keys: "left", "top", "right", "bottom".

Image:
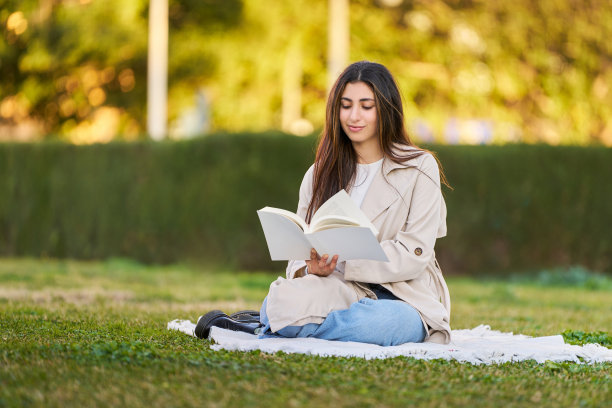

{"left": 0, "top": 259, "right": 612, "bottom": 407}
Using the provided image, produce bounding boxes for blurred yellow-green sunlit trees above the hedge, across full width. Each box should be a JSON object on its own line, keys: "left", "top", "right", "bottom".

{"left": 0, "top": 0, "right": 612, "bottom": 146}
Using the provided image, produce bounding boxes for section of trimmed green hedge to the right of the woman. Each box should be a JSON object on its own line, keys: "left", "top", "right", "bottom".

{"left": 437, "top": 145, "right": 612, "bottom": 272}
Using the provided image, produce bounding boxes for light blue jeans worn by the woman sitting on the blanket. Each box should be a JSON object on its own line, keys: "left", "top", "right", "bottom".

{"left": 259, "top": 286, "right": 427, "bottom": 346}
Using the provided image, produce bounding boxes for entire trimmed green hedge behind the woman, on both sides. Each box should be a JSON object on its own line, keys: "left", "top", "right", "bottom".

{"left": 0, "top": 133, "right": 612, "bottom": 273}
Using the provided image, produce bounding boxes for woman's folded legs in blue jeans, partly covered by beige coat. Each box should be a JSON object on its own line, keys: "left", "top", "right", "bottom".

{"left": 260, "top": 274, "right": 426, "bottom": 346}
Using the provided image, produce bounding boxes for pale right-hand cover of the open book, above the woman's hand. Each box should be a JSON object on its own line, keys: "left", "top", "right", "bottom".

{"left": 306, "top": 227, "right": 389, "bottom": 262}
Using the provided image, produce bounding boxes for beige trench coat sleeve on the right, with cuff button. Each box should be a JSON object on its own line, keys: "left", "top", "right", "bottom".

{"left": 344, "top": 154, "right": 446, "bottom": 283}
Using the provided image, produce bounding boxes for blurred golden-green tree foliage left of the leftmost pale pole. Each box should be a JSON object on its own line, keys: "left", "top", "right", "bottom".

{"left": 2, "top": 0, "right": 146, "bottom": 140}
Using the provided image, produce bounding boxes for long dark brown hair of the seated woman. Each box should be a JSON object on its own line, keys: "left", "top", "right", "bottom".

{"left": 306, "top": 61, "right": 448, "bottom": 222}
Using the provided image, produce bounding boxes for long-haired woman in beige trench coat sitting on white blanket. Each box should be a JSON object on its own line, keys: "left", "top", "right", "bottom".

{"left": 196, "top": 61, "right": 450, "bottom": 346}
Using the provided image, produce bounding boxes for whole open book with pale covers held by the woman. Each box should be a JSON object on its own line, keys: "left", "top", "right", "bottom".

{"left": 257, "top": 190, "right": 389, "bottom": 262}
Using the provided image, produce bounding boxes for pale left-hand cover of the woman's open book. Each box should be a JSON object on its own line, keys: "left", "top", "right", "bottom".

{"left": 257, "top": 209, "right": 312, "bottom": 261}
